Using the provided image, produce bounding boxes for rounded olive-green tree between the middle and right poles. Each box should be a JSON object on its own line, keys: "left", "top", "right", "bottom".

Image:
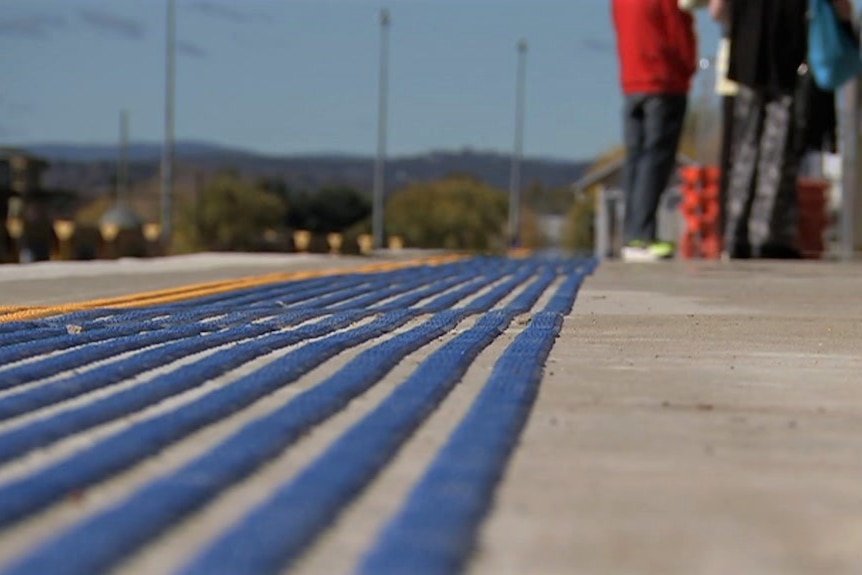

{"left": 386, "top": 175, "right": 508, "bottom": 251}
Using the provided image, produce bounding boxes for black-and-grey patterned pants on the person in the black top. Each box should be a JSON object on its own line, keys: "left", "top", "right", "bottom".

{"left": 724, "top": 86, "right": 800, "bottom": 257}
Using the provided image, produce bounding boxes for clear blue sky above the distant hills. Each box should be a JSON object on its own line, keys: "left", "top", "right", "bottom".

{"left": 0, "top": 0, "right": 717, "bottom": 159}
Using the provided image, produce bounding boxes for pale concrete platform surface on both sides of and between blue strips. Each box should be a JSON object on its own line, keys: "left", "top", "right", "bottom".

{"left": 0, "top": 254, "right": 862, "bottom": 575}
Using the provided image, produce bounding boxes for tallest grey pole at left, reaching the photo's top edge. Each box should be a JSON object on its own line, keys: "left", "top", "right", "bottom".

{"left": 162, "top": 0, "right": 177, "bottom": 250}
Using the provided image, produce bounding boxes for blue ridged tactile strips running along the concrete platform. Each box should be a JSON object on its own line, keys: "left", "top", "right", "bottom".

{"left": 0, "top": 258, "right": 596, "bottom": 574}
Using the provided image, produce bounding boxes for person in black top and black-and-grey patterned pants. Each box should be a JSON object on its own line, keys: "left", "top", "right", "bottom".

{"left": 710, "top": 0, "right": 852, "bottom": 259}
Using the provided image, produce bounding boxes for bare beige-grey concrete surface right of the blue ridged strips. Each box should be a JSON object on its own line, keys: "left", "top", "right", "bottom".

{"left": 475, "top": 262, "right": 862, "bottom": 575}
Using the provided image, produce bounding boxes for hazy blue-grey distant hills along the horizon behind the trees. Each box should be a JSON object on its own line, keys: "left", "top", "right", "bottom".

{"left": 21, "top": 141, "right": 590, "bottom": 205}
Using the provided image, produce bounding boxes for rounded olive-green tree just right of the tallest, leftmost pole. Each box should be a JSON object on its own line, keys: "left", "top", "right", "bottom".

{"left": 177, "top": 171, "right": 286, "bottom": 251}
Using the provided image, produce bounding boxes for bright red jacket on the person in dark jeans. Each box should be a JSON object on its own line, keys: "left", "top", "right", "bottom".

{"left": 612, "top": 0, "right": 697, "bottom": 94}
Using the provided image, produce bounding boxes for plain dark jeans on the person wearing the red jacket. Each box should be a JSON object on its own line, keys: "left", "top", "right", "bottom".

{"left": 623, "top": 94, "right": 688, "bottom": 243}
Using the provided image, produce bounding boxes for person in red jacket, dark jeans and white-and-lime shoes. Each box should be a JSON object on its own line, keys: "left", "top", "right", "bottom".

{"left": 611, "top": 0, "right": 697, "bottom": 261}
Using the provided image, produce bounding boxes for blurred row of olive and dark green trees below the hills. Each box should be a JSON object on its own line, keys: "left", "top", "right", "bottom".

{"left": 154, "top": 170, "right": 592, "bottom": 252}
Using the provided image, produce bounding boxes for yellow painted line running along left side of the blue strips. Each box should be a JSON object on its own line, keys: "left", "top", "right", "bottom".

{"left": 0, "top": 255, "right": 465, "bottom": 323}
